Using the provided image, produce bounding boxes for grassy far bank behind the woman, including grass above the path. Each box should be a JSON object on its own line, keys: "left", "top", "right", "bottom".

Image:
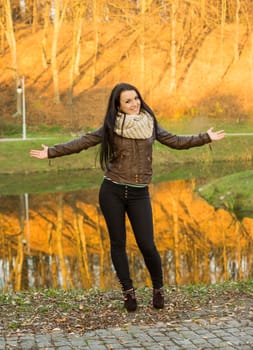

{"left": 0, "top": 118, "right": 253, "bottom": 178}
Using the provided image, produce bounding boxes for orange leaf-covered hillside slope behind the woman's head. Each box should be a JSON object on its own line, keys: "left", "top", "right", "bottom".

{"left": 0, "top": 23, "right": 253, "bottom": 130}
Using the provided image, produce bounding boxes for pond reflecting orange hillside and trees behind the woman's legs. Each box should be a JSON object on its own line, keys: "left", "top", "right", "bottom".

{"left": 0, "top": 163, "right": 253, "bottom": 291}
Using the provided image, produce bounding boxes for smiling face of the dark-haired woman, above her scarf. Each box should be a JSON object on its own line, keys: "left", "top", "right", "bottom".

{"left": 119, "top": 90, "right": 141, "bottom": 114}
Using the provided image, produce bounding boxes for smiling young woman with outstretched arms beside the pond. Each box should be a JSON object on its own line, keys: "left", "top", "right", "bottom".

{"left": 30, "top": 83, "right": 225, "bottom": 311}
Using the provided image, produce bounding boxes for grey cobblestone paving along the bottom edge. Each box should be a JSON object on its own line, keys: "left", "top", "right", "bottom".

{"left": 0, "top": 318, "right": 253, "bottom": 350}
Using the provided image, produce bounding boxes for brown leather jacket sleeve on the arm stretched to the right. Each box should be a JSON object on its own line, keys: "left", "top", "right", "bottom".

{"left": 156, "top": 125, "right": 212, "bottom": 149}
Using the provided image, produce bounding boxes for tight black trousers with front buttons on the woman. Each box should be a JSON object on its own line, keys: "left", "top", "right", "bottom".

{"left": 99, "top": 179, "right": 163, "bottom": 290}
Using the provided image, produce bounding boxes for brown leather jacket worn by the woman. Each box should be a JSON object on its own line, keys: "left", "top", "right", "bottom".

{"left": 48, "top": 125, "right": 211, "bottom": 185}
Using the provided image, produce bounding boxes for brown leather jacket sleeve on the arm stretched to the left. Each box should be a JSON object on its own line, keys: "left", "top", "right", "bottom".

{"left": 48, "top": 127, "right": 103, "bottom": 158}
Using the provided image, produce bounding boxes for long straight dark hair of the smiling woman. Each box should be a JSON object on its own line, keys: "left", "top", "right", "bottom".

{"left": 100, "top": 83, "right": 157, "bottom": 170}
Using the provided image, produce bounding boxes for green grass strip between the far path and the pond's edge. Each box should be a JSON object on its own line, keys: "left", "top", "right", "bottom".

{"left": 0, "top": 129, "right": 253, "bottom": 174}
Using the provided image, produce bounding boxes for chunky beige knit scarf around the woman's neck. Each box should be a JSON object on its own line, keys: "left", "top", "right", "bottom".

{"left": 114, "top": 111, "right": 154, "bottom": 140}
